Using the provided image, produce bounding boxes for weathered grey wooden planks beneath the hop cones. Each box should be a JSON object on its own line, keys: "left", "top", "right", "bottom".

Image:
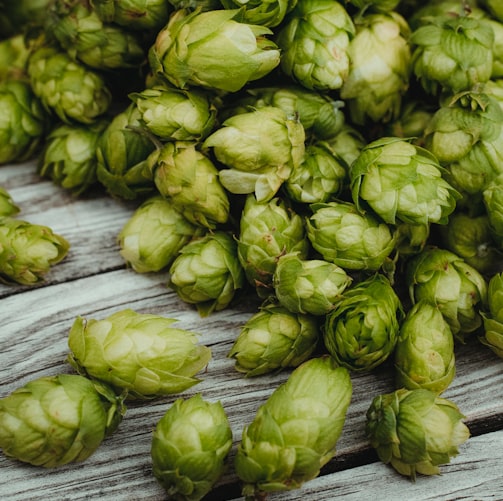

{"left": 0, "top": 162, "right": 503, "bottom": 501}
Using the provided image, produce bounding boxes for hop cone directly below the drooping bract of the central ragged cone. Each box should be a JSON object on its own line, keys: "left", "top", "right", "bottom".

{"left": 237, "top": 195, "right": 309, "bottom": 297}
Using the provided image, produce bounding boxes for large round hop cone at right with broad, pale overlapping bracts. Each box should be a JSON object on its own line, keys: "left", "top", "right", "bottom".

{"left": 349, "top": 137, "right": 459, "bottom": 225}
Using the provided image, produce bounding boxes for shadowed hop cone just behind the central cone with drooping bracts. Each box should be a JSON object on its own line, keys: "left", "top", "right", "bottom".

{"left": 223, "top": 84, "right": 345, "bottom": 140}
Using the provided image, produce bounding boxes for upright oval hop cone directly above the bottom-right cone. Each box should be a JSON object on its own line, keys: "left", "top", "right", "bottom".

{"left": 394, "top": 300, "right": 456, "bottom": 394}
